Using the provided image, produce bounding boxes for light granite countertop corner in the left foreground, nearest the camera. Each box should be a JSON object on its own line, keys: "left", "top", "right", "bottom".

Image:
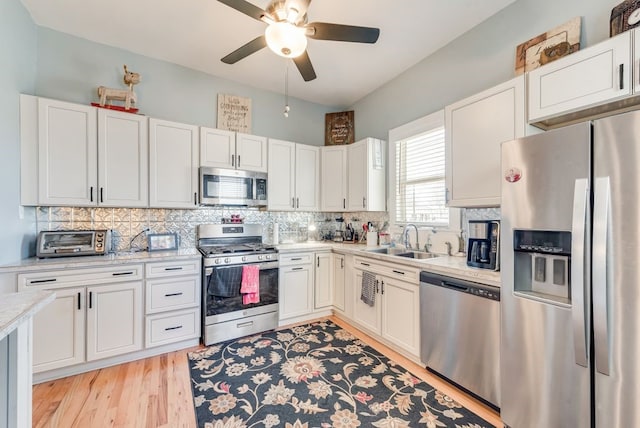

{"left": 0, "top": 290, "right": 55, "bottom": 340}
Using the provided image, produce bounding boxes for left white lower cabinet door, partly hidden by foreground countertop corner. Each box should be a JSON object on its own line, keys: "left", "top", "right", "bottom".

{"left": 33, "top": 287, "right": 85, "bottom": 373}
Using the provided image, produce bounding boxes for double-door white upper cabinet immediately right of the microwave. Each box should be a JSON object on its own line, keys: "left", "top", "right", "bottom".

{"left": 267, "top": 139, "right": 320, "bottom": 211}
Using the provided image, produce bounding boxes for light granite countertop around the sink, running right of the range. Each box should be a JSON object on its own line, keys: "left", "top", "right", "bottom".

{"left": 278, "top": 241, "right": 500, "bottom": 287}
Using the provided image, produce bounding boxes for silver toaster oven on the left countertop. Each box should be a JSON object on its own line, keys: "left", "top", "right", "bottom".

{"left": 36, "top": 229, "right": 111, "bottom": 258}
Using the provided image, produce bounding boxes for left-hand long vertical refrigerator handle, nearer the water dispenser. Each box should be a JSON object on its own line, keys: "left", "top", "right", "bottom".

{"left": 571, "top": 178, "right": 589, "bottom": 367}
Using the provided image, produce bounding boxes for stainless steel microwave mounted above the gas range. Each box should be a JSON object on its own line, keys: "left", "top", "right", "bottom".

{"left": 200, "top": 167, "right": 267, "bottom": 207}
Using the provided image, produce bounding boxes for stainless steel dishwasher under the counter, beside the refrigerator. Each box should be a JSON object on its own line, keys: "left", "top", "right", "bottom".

{"left": 420, "top": 272, "right": 500, "bottom": 408}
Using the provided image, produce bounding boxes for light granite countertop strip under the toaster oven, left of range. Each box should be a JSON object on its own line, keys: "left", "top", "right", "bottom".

{"left": 0, "top": 248, "right": 201, "bottom": 273}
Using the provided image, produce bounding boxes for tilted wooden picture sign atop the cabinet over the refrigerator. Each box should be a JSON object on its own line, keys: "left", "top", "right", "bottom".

{"left": 516, "top": 16, "right": 581, "bottom": 75}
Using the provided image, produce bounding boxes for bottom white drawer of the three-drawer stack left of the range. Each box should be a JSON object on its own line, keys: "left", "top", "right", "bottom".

{"left": 145, "top": 308, "right": 200, "bottom": 348}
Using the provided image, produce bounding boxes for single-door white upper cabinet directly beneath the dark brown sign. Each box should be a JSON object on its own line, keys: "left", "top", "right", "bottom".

{"left": 320, "top": 146, "right": 347, "bottom": 212}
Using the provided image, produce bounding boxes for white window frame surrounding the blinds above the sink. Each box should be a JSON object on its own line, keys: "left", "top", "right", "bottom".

{"left": 387, "top": 110, "right": 461, "bottom": 231}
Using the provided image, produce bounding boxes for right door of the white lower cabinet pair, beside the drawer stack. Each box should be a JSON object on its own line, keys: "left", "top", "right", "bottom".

{"left": 87, "top": 281, "right": 144, "bottom": 361}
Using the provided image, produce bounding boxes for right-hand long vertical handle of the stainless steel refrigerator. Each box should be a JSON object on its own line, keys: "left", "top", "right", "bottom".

{"left": 592, "top": 177, "right": 611, "bottom": 376}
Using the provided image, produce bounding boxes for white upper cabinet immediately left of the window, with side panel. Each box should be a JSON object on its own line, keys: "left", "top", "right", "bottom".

{"left": 347, "top": 138, "right": 387, "bottom": 211}
